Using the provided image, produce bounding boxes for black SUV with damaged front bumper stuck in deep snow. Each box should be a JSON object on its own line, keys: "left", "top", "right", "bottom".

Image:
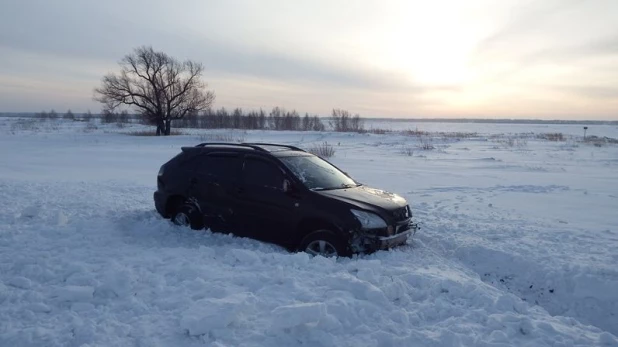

{"left": 154, "top": 143, "right": 417, "bottom": 256}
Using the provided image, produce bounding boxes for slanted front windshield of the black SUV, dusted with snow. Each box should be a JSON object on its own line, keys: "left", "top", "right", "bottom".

{"left": 280, "top": 156, "right": 360, "bottom": 190}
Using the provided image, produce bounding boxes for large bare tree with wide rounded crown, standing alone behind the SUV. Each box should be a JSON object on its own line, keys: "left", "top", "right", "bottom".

{"left": 95, "top": 47, "right": 215, "bottom": 135}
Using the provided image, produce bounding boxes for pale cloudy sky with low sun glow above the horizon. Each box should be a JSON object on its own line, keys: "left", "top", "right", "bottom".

{"left": 0, "top": 0, "right": 618, "bottom": 120}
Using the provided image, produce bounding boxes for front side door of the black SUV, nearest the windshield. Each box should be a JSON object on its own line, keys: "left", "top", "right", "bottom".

{"left": 240, "top": 155, "right": 300, "bottom": 244}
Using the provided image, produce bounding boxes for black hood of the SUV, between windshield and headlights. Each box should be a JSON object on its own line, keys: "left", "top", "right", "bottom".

{"left": 317, "top": 186, "right": 407, "bottom": 215}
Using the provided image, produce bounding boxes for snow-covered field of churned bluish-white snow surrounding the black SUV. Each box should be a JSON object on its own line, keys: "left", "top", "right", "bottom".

{"left": 0, "top": 118, "right": 618, "bottom": 346}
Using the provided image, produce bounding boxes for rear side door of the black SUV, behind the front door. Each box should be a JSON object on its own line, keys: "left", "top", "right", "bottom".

{"left": 191, "top": 152, "right": 242, "bottom": 233}
